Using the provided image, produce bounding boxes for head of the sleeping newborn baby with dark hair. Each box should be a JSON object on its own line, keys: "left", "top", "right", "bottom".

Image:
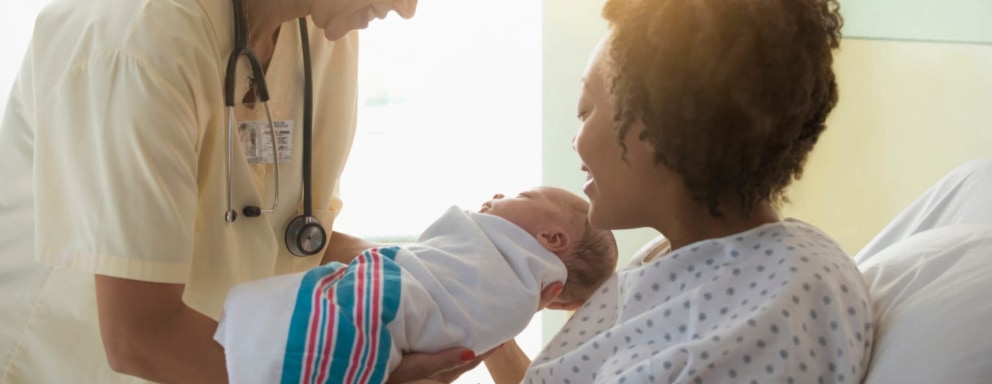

{"left": 479, "top": 187, "right": 617, "bottom": 309}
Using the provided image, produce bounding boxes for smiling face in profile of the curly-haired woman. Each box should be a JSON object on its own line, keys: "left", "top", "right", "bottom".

{"left": 572, "top": 40, "right": 661, "bottom": 229}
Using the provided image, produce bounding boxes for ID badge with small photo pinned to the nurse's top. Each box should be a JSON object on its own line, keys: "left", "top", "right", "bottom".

{"left": 238, "top": 120, "right": 293, "bottom": 164}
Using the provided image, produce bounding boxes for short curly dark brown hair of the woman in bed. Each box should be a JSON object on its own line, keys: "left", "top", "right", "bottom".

{"left": 603, "top": 0, "right": 843, "bottom": 217}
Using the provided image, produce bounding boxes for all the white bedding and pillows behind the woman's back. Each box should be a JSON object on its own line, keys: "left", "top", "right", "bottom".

{"left": 855, "top": 159, "right": 992, "bottom": 384}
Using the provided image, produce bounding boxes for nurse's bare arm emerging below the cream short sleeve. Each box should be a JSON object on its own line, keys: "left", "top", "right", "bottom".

{"left": 96, "top": 276, "right": 227, "bottom": 383}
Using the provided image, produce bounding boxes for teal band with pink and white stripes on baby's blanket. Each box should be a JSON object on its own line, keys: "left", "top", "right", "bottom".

{"left": 282, "top": 247, "right": 401, "bottom": 384}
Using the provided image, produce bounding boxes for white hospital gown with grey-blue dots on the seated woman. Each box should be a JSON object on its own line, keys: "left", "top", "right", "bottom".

{"left": 524, "top": 220, "right": 872, "bottom": 384}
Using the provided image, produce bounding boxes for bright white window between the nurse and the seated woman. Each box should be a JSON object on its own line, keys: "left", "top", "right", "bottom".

{"left": 334, "top": 0, "right": 542, "bottom": 383}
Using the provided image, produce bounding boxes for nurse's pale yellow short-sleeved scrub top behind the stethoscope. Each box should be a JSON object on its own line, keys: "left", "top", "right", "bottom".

{"left": 0, "top": 0, "right": 358, "bottom": 384}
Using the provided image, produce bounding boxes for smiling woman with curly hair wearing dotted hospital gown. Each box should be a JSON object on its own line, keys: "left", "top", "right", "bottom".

{"left": 406, "top": 0, "right": 872, "bottom": 383}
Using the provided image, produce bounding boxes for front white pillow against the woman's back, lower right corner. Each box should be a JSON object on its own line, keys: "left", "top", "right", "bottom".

{"left": 858, "top": 224, "right": 992, "bottom": 384}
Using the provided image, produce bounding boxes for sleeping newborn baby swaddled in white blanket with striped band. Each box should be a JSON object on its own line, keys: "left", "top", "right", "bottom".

{"left": 215, "top": 187, "right": 617, "bottom": 383}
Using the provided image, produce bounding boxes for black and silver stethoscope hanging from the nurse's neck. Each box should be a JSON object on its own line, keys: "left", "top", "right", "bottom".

{"left": 224, "top": 0, "right": 327, "bottom": 257}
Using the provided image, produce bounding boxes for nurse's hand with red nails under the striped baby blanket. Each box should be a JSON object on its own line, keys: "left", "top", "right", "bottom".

{"left": 386, "top": 348, "right": 492, "bottom": 384}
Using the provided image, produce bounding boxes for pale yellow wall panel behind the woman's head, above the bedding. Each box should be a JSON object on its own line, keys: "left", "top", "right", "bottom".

{"left": 784, "top": 39, "right": 992, "bottom": 254}
